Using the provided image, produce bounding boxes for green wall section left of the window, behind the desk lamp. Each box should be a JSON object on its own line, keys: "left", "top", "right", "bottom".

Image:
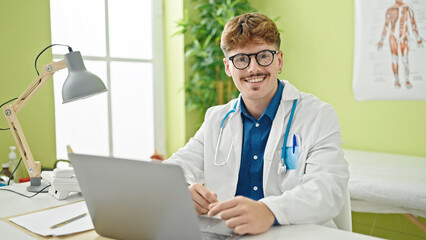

{"left": 0, "top": 0, "right": 56, "bottom": 177}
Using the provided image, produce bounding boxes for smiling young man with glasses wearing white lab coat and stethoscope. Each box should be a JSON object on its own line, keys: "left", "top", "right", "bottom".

{"left": 166, "top": 13, "right": 349, "bottom": 234}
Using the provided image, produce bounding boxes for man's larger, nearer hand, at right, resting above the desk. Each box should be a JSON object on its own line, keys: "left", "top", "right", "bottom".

{"left": 208, "top": 196, "right": 275, "bottom": 235}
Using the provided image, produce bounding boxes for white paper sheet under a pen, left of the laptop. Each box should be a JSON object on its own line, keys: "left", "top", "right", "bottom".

{"left": 10, "top": 201, "right": 94, "bottom": 236}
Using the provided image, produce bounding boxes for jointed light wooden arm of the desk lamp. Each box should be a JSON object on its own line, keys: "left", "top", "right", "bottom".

{"left": 3, "top": 60, "right": 67, "bottom": 177}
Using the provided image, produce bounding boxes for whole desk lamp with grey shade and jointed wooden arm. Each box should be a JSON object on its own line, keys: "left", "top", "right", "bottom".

{"left": 3, "top": 45, "right": 107, "bottom": 192}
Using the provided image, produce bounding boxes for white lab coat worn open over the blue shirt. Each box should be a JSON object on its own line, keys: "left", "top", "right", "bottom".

{"left": 165, "top": 81, "right": 349, "bottom": 227}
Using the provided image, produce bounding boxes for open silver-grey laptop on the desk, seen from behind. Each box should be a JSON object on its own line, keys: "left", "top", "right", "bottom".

{"left": 69, "top": 154, "right": 239, "bottom": 240}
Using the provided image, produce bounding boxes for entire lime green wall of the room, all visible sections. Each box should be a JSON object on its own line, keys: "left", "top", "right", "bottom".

{"left": 0, "top": 0, "right": 426, "bottom": 239}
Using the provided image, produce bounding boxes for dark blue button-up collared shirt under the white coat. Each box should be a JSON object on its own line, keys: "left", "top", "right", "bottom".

{"left": 235, "top": 80, "right": 284, "bottom": 201}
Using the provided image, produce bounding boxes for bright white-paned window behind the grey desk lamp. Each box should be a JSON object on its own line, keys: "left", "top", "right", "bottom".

{"left": 50, "top": 0, "right": 166, "bottom": 159}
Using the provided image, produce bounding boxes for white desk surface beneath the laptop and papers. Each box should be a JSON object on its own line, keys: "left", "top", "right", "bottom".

{"left": 0, "top": 184, "right": 378, "bottom": 240}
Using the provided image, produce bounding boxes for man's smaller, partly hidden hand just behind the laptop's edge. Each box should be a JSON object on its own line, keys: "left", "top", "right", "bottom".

{"left": 188, "top": 183, "right": 217, "bottom": 215}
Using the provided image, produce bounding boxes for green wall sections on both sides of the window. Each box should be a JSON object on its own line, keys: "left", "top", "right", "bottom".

{"left": 0, "top": 0, "right": 186, "bottom": 169}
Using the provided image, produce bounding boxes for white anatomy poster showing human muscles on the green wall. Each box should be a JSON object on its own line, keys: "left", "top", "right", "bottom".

{"left": 353, "top": 0, "right": 426, "bottom": 101}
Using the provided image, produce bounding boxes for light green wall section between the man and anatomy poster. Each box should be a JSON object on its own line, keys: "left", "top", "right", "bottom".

{"left": 251, "top": 0, "right": 426, "bottom": 157}
